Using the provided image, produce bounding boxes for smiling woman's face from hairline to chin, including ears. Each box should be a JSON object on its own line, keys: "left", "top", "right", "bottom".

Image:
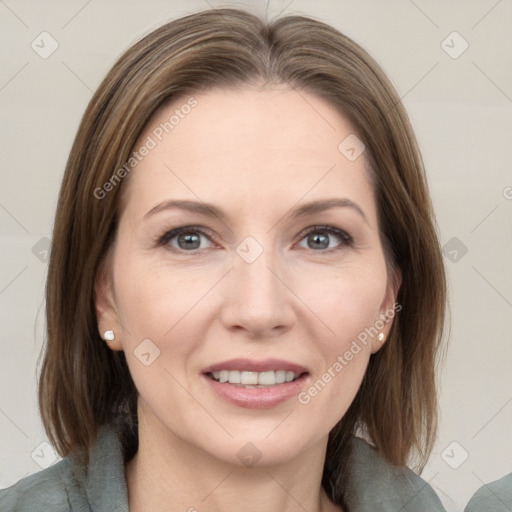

{"left": 97, "top": 86, "right": 396, "bottom": 464}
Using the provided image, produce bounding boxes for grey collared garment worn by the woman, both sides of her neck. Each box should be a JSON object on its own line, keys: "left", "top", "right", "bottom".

{"left": 0, "top": 425, "right": 446, "bottom": 512}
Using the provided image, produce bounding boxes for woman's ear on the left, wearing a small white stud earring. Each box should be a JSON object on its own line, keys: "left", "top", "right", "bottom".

{"left": 94, "top": 257, "right": 123, "bottom": 350}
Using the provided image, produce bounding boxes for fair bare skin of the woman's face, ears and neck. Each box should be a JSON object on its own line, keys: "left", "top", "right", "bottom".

{"left": 96, "top": 85, "right": 397, "bottom": 512}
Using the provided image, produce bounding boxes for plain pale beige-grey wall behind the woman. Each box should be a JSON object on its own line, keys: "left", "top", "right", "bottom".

{"left": 0, "top": 0, "right": 512, "bottom": 512}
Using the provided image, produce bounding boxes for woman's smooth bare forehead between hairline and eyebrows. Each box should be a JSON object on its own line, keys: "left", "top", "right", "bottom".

{"left": 120, "top": 85, "right": 372, "bottom": 223}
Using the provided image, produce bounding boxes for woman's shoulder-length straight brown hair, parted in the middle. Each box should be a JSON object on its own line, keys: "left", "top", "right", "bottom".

{"left": 39, "top": 9, "right": 446, "bottom": 504}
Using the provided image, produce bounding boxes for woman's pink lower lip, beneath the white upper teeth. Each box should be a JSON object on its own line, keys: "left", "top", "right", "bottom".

{"left": 202, "top": 374, "right": 309, "bottom": 409}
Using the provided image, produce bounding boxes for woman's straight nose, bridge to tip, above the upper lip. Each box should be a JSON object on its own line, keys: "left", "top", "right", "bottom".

{"left": 224, "top": 237, "right": 292, "bottom": 334}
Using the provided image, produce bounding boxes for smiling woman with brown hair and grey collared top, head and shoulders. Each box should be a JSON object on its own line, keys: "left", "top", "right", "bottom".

{"left": 0, "top": 9, "right": 446, "bottom": 512}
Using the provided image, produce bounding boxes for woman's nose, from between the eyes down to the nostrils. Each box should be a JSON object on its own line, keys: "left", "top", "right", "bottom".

{"left": 221, "top": 241, "right": 295, "bottom": 339}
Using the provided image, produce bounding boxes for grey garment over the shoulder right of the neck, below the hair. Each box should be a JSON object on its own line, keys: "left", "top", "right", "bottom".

{"left": 347, "top": 437, "right": 446, "bottom": 512}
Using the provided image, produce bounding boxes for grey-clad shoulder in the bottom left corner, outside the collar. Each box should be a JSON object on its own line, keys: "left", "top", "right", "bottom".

{"left": 0, "top": 459, "right": 75, "bottom": 512}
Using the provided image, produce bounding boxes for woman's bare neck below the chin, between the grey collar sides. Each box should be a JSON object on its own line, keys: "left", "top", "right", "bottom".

{"left": 125, "top": 400, "right": 341, "bottom": 512}
